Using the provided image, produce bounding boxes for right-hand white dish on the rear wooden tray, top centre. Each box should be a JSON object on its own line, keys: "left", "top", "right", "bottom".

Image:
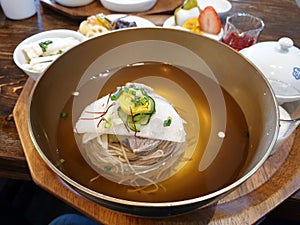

{"left": 100, "top": 0, "right": 157, "bottom": 13}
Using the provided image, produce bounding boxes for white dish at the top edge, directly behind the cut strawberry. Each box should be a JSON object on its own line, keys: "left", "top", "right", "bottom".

{"left": 197, "top": 0, "right": 232, "bottom": 17}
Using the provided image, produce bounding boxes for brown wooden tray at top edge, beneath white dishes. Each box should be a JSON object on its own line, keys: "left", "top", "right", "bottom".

{"left": 40, "top": 0, "right": 183, "bottom": 20}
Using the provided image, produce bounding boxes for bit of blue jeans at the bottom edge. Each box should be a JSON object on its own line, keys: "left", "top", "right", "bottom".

{"left": 49, "top": 214, "right": 100, "bottom": 225}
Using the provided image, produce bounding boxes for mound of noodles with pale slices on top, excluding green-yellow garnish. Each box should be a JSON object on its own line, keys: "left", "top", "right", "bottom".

{"left": 75, "top": 84, "right": 185, "bottom": 188}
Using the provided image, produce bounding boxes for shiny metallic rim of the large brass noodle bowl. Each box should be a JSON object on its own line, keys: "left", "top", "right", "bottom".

{"left": 28, "top": 27, "right": 279, "bottom": 208}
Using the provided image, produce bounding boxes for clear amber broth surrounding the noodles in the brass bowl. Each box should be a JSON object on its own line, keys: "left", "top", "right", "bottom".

{"left": 58, "top": 63, "right": 249, "bottom": 202}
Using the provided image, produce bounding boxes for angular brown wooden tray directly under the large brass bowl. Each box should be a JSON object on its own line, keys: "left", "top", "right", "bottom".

{"left": 13, "top": 78, "right": 300, "bottom": 225}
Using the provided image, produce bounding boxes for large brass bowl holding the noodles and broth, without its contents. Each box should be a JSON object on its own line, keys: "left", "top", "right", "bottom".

{"left": 29, "top": 28, "right": 279, "bottom": 216}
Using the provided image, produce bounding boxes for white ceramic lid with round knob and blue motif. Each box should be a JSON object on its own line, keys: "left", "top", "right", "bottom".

{"left": 240, "top": 37, "right": 300, "bottom": 103}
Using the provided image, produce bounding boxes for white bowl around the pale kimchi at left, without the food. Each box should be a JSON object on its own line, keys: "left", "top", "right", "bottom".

{"left": 13, "top": 29, "right": 86, "bottom": 80}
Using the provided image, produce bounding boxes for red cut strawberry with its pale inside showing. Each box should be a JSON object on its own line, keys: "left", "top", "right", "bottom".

{"left": 198, "top": 6, "right": 222, "bottom": 34}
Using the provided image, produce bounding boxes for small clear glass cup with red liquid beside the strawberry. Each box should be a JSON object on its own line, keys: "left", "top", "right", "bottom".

{"left": 222, "top": 13, "right": 264, "bottom": 51}
